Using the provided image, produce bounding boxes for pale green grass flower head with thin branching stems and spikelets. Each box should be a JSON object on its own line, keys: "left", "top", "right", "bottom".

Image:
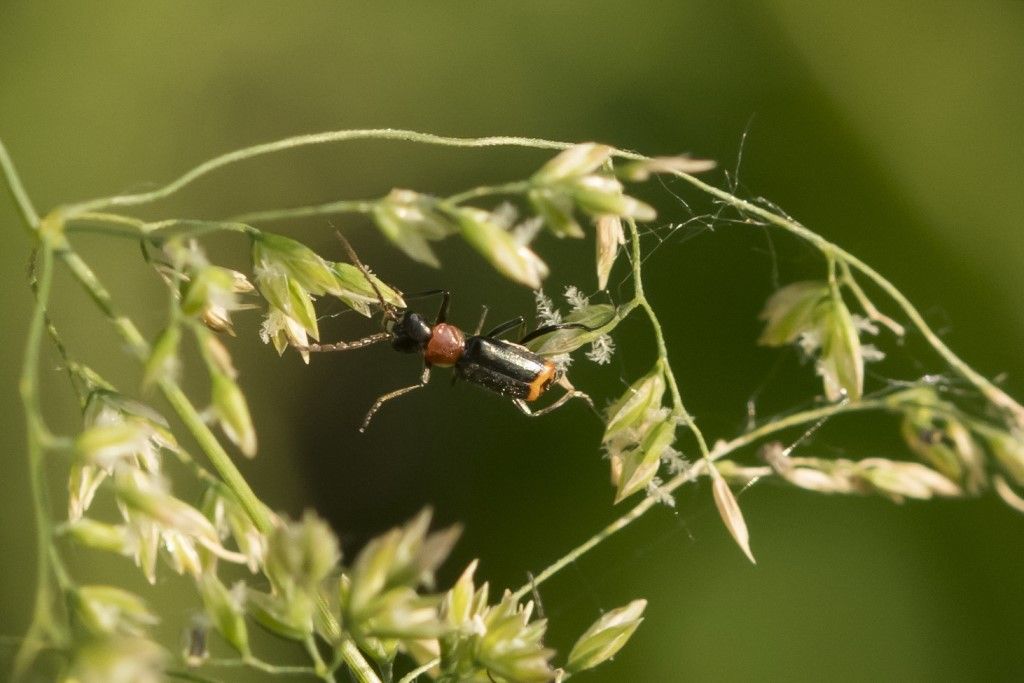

{"left": 0, "top": 129, "right": 1024, "bottom": 683}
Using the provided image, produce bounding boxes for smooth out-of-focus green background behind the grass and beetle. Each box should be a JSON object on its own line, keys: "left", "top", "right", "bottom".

{"left": 0, "top": 0, "right": 1024, "bottom": 682}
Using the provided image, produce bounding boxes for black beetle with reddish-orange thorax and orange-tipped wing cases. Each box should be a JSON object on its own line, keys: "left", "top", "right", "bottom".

{"left": 304, "top": 234, "right": 597, "bottom": 432}
